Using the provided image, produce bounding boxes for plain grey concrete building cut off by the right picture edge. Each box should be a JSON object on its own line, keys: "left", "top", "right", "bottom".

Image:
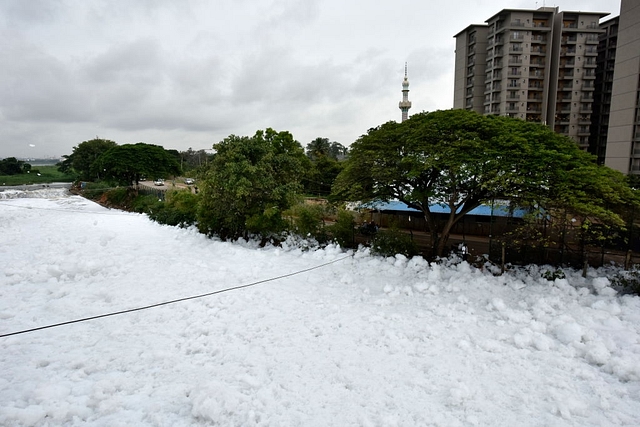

{"left": 605, "top": 0, "right": 640, "bottom": 174}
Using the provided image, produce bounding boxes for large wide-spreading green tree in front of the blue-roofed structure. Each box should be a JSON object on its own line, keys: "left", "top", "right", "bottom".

{"left": 333, "top": 110, "right": 633, "bottom": 255}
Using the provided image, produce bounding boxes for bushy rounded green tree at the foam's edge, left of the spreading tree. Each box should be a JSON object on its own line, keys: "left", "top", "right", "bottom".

{"left": 198, "top": 128, "right": 309, "bottom": 239}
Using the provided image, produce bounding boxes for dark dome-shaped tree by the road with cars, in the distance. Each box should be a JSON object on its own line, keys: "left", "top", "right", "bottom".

{"left": 97, "top": 142, "right": 180, "bottom": 185}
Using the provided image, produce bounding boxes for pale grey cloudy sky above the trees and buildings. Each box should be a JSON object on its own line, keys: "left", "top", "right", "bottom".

{"left": 0, "top": 0, "right": 620, "bottom": 158}
